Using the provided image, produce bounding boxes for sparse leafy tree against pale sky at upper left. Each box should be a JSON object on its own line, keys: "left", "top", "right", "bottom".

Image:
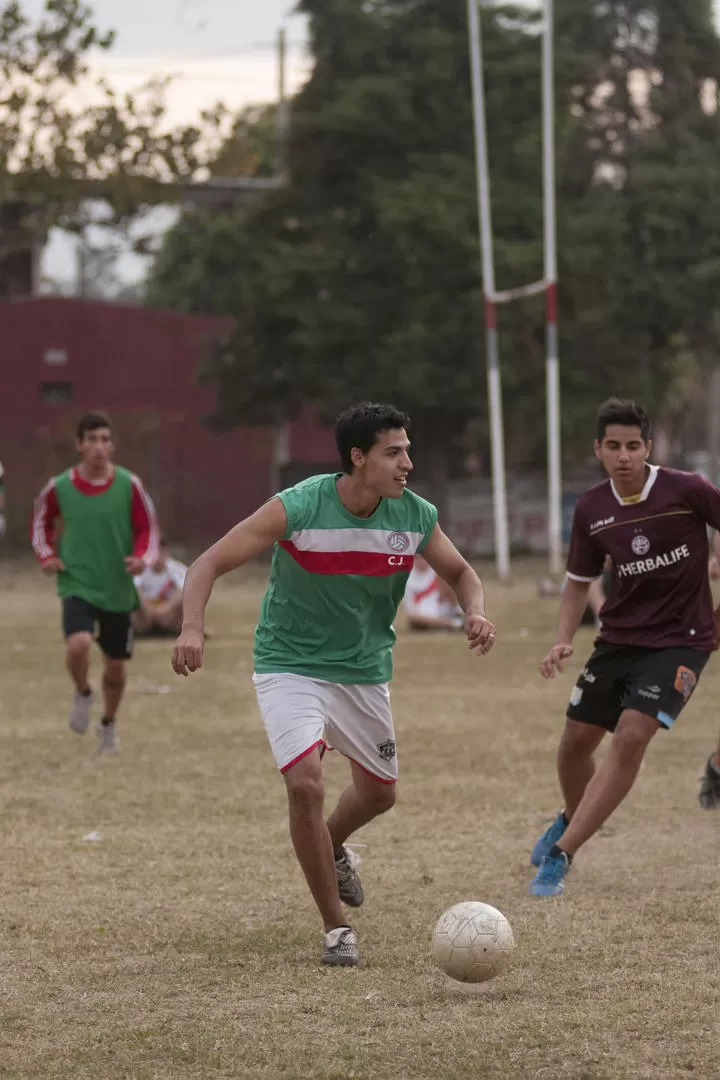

{"left": 0, "top": 0, "right": 225, "bottom": 267}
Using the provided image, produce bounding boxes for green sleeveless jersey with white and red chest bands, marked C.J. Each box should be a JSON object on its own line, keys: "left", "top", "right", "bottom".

{"left": 255, "top": 473, "right": 437, "bottom": 684}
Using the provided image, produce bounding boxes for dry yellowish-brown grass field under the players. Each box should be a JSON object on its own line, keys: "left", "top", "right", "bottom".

{"left": 0, "top": 567, "right": 720, "bottom": 1080}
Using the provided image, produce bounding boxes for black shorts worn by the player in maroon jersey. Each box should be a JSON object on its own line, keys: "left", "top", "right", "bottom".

{"left": 568, "top": 642, "right": 710, "bottom": 731}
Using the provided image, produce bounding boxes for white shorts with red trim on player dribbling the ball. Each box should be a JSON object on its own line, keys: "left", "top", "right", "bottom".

{"left": 253, "top": 673, "right": 397, "bottom": 784}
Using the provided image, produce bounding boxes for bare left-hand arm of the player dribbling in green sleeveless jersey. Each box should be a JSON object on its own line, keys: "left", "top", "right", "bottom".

{"left": 173, "top": 499, "right": 287, "bottom": 675}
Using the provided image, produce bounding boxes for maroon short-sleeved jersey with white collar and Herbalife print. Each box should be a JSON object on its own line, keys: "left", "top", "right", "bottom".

{"left": 568, "top": 465, "right": 720, "bottom": 650}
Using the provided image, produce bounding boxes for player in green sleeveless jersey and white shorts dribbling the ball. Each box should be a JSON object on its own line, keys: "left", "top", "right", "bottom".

{"left": 173, "top": 404, "right": 494, "bottom": 966}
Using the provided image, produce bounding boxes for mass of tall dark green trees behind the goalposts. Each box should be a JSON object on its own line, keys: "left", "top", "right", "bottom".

{"left": 147, "top": 0, "right": 720, "bottom": 488}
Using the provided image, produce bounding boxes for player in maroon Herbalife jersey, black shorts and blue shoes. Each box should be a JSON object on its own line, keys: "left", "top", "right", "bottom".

{"left": 530, "top": 397, "right": 720, "bottom": 896}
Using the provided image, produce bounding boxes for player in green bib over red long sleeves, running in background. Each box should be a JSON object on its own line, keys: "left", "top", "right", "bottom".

{"left": 32, "top": 413, "right": 159, "bottom": 753}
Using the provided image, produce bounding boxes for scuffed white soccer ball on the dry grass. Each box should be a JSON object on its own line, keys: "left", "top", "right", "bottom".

{"left": 433, "top": 900, "right": 515, "bottom": 983}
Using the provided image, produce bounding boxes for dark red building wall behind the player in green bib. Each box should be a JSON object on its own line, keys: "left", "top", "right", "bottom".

{"left": 0, "top": 297, "right": 336, "bottom": 548}
